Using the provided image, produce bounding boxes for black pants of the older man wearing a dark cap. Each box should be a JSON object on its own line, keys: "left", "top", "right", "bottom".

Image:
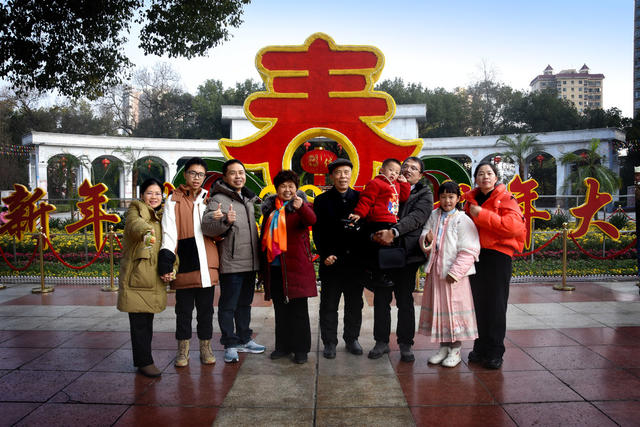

{"left": 320, "top": 267, "right": 364, "bottom": 344}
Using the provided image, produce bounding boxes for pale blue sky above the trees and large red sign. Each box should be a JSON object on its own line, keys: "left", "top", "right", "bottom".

{"left": 127, "top": 0, "right": 634, "bottom": 117}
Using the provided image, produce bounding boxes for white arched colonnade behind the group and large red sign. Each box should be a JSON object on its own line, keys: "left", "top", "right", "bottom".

{"left": 22, "top": 105, "right": 625, "bottom": 198}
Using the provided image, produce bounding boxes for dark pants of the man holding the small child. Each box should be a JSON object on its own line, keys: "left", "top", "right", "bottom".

{"left": 373, "top": 263, "right": 422, "bottom": 345}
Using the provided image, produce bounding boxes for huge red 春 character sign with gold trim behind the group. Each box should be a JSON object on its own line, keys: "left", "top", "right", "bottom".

{"left": 220, "top": 33, "right": 422, "bottom": 186}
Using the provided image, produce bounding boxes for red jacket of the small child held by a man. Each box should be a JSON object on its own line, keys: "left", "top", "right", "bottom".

{"left": 353, "top": 175, "right": 411, "bottom": 223}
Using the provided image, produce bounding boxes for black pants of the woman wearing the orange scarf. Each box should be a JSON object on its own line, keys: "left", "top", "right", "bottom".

{"left": 270, "top": 266, "right": 311, "bottom": 353}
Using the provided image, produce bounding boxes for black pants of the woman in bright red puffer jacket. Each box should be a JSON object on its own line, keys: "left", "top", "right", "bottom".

{"left": 469, "top": 249, "right": 511, "bottom": 359}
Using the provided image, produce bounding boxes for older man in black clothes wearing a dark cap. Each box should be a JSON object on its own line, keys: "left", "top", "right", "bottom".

{"left": 313, "top": 159, "right": 363, "bottom": 359}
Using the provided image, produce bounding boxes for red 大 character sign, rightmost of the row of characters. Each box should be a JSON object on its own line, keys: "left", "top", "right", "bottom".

{"left": 569, "top": 178, "right": 620, "bottom": 240}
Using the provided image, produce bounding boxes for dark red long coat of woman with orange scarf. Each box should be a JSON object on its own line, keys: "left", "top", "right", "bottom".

{"left": 260, "top": 192, "right": 318, "bottom": 300}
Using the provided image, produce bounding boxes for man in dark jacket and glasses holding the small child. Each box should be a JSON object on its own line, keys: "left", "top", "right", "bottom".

{"left": 369, "top": 157, "right": 433, "bottom": 362}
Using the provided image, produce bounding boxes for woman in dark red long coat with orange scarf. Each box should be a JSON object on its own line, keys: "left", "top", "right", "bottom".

{"left": 261, "top": 170, "right": 318, "bottom": 363}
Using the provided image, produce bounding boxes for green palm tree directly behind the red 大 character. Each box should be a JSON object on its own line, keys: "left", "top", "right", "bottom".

{"left": 560, "top": 138, "right": 622, "bottom": 194}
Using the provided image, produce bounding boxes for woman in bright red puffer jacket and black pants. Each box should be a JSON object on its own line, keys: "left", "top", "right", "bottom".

{"left": 464, "top": 162, "right": 525, "bottom": 369}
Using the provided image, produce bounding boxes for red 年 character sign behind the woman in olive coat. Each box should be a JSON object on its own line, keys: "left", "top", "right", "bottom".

{"left": 65, "top": 179, "right": 120, "bottom": 250}
